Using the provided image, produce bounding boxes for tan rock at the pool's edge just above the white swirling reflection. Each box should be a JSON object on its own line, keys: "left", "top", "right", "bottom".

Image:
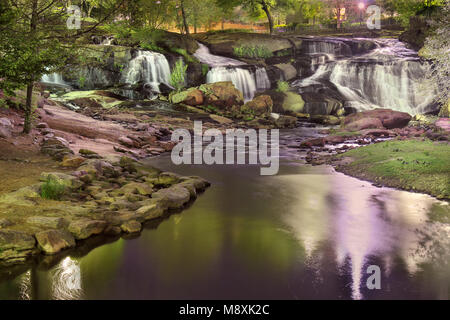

{"left": 35, "top": 230, "right": 75, "bottom": 254}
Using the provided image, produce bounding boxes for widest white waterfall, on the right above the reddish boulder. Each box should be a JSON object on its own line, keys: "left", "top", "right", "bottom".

{"left": 293, "top": 39, "right": 434, "bottom": 115}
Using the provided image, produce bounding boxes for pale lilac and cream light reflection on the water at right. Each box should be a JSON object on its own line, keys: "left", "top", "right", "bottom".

{"left": 279, "top": 169, "right": 450, "bottom": 299}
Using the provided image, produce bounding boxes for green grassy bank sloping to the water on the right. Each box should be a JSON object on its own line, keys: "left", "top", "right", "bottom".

{"left": 336, "top": 140, "right": 450, "bottom": 199}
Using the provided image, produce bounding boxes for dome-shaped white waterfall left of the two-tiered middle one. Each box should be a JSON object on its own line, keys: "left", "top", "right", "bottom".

{"left": 124, "top": 51, "right": 170, "bottom": 92}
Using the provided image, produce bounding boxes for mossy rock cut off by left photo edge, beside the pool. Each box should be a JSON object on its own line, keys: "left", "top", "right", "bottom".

{"left": 0, "top": 229, "right": 36, "bottom": 263}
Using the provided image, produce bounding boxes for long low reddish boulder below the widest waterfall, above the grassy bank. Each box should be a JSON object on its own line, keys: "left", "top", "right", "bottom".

{"left": 343, "top": 109, "right": 412, "bottom": 130}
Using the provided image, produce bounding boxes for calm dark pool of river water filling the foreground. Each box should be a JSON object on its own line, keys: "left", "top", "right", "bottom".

{"left": 0, "top": 128, "right": 450, "bottom": 299}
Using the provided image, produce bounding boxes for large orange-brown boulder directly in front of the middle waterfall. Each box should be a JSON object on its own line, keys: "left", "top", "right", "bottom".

{"left": 198, "top": 81, "right": 244, "bottom": 109}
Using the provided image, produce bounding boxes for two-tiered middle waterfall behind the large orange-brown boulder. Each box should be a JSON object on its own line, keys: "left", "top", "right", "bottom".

{"left": 194, "top": 43, "right": 270, "bottom": 101}
